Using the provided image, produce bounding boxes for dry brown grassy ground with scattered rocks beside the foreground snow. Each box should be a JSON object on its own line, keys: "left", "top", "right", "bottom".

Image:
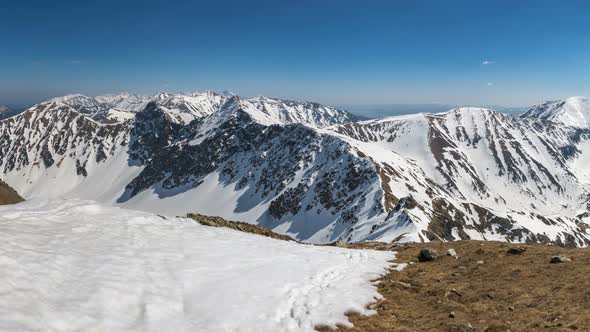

{"left": 318, "top": 241, "right": 590, "bottom": 331}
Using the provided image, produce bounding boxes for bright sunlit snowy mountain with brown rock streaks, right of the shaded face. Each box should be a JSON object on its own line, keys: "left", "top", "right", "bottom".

{"left": 330, "top": 108, "right": 590, "bottom": 245}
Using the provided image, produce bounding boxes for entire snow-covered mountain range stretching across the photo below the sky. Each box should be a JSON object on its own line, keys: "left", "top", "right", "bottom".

{"left": 0, "top": 92, "right": 590, "bottom": 246}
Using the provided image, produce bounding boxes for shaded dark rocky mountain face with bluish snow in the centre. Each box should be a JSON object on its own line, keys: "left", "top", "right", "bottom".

{"left": 118, "top": 97, "right": 434, "bottom": 242}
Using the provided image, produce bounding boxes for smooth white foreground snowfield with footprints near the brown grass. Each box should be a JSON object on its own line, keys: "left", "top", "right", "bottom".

{"left": 0, "top": 200, "right": 394, "bottom": 331}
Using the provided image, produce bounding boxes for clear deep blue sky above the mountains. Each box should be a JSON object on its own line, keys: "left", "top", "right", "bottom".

{"left": 0, "top": 0, "right": 590, "bottom": 105}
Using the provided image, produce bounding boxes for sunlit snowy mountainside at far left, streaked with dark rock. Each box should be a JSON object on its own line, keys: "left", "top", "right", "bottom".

{"left": 0, "top": 101, "right": 134, "bottom": 197}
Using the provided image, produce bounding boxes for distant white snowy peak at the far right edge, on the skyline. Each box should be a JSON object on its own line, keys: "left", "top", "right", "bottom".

{"left": 521, "top": 97, "right": 590, "bottom": 128}
